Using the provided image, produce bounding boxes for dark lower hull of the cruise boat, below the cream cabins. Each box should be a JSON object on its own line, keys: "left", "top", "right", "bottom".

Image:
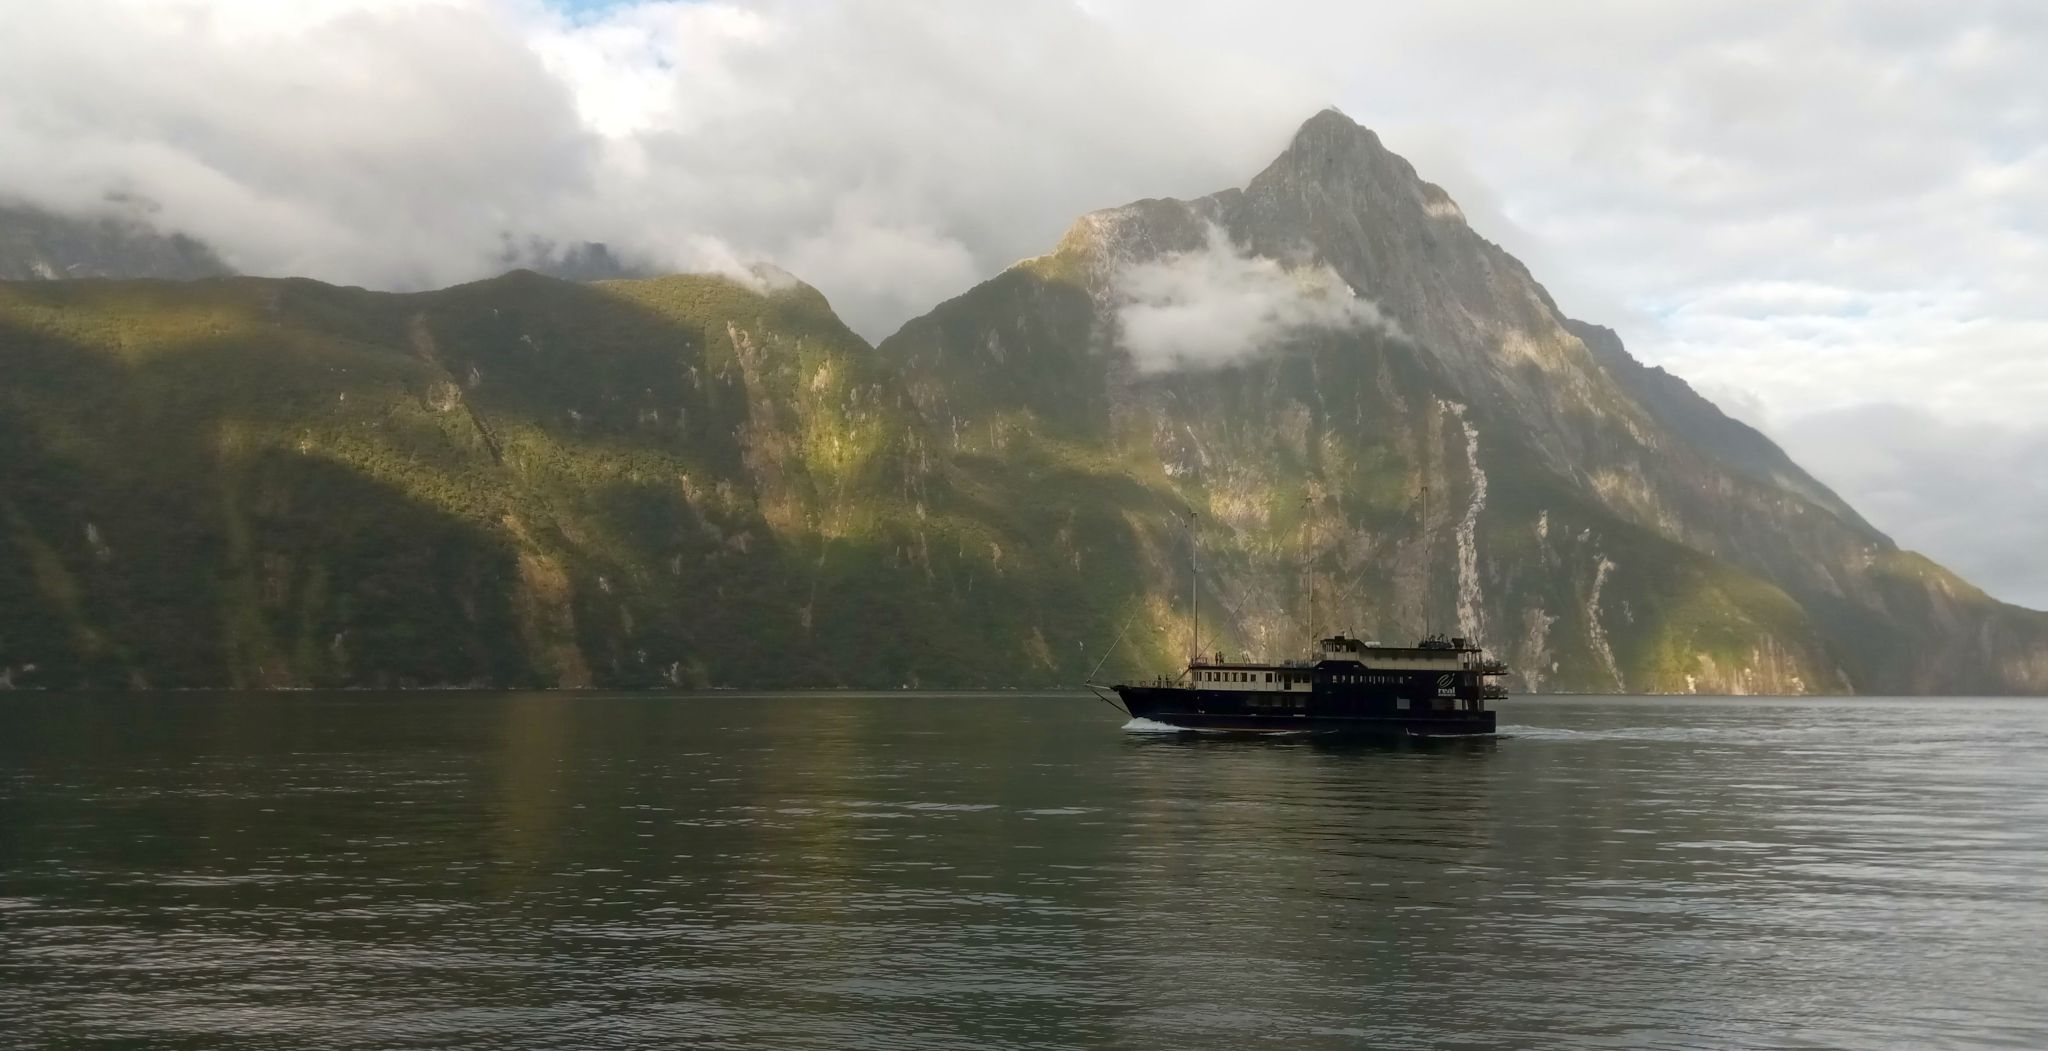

{"left": 1116, "top": 686, "right": 1495, "bottom": 738}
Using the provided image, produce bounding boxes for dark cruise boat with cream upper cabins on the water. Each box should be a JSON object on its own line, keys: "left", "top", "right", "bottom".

{"left": 1108, "top": 635, "right": 1507, "bottom": 738}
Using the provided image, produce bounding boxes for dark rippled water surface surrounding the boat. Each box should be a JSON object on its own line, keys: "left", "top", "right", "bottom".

{"left": 0, "top": 695, "right": 2048, "bottom": 1049}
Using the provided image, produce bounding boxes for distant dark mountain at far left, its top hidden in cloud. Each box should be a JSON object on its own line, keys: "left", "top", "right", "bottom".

{"left": 0, "top": 203, "right": 229, "bottom": 281}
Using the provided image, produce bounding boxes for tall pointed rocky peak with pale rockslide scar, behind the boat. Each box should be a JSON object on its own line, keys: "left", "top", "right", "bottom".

{"left": 881, "top": 111, "right": 2048, "bottom": 692}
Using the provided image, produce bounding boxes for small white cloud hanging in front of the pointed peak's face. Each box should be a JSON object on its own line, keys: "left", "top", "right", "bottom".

{"left": 1112, "top": 223, "right": 1401, "bottom": 373}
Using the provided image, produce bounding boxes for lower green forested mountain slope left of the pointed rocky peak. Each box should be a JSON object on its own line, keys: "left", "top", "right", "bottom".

{"left": 0, "top": 272, "right": 1163, "bottom": 686}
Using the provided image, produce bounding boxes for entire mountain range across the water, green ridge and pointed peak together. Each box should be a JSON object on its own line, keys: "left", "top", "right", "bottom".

{"left": 0, "top": 111, "right": 2048, "bottom": 692}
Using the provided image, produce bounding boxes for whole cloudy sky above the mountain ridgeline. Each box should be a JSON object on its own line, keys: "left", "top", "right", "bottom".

{"left": 0, "top": 0, "right": 2048, "bottom": 608}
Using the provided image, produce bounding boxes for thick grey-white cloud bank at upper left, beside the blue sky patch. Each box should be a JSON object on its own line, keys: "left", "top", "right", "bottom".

{"left": 0, "top": 0, "right": 594, "bottom": 287}
